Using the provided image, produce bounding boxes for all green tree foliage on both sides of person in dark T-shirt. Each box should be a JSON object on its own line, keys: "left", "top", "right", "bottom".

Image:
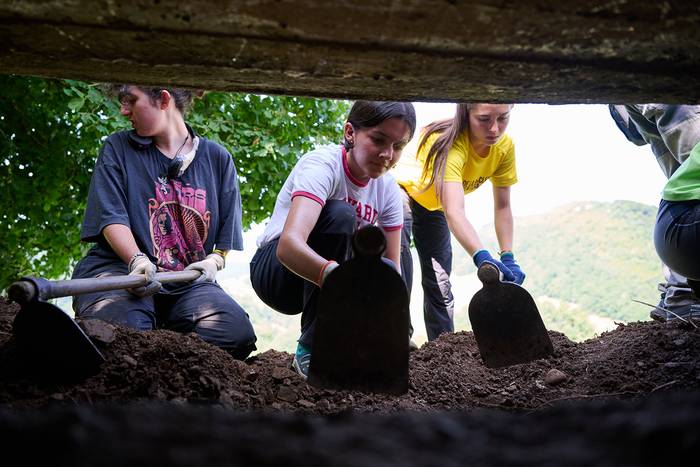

{"left": 0, "top": 76, "right": 349, "bottom": 289}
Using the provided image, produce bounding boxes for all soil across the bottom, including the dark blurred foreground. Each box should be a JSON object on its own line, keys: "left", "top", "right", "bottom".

{"left": 0, "top": 298, "right": 700, "bottom": 467}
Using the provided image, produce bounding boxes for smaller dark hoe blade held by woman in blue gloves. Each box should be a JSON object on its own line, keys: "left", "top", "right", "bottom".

{"left": 469, "top": 263, "right": 554, "bottom": 368}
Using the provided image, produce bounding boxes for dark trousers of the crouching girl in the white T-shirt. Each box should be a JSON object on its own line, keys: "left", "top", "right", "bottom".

{"left": 250, "top": 200, "right": 357, "bottom": 349}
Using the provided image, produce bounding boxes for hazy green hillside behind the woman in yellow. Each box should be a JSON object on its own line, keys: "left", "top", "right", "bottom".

{"left": 455, "top": 201, "right": 663, "bottom": 322}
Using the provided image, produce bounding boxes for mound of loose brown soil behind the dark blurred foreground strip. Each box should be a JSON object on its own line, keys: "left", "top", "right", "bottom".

{"left": 0, "top": 303, "right": 700, "bottom": 415}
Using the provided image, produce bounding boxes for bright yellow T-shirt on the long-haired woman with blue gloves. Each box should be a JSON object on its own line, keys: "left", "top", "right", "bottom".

{"left": 393, "top": 131, "right": 518, "bottom": 211}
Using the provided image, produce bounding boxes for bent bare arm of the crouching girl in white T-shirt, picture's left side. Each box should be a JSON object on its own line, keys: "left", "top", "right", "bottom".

{"left": 277, "top": 196, "right": 328, "bottom": 284}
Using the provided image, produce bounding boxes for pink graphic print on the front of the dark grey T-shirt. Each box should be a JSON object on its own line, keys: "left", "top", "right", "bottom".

{"left": 148, "top": 180, "right": 211, "bottom": 271}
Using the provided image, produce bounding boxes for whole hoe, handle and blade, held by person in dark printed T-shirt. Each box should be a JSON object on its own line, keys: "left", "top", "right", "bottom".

{"left": 7, "top": 271, "right": 201, "bottom": 380}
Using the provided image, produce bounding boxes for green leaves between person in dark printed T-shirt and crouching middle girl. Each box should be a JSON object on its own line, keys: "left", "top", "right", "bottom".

{"left": 187, "top": 92, "right": 349, "bottom": 228}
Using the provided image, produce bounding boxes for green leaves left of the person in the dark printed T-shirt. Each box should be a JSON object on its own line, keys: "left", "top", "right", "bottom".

{"left": 0, "top": 76, "right": 124, "bottom": 288}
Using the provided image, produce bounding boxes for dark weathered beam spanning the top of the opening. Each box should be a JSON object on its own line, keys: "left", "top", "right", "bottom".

{"left": 0, "top": 0, "right": 700, "bottom": 103}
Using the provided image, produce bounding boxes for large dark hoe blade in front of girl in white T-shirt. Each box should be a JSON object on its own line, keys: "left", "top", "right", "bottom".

{"left": 309, "top": 226, "right": 409, "bottom": 394}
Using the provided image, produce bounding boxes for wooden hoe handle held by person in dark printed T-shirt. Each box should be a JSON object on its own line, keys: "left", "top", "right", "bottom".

{"left": 7, "top": 271, "right": 201, "bottom": 304}
